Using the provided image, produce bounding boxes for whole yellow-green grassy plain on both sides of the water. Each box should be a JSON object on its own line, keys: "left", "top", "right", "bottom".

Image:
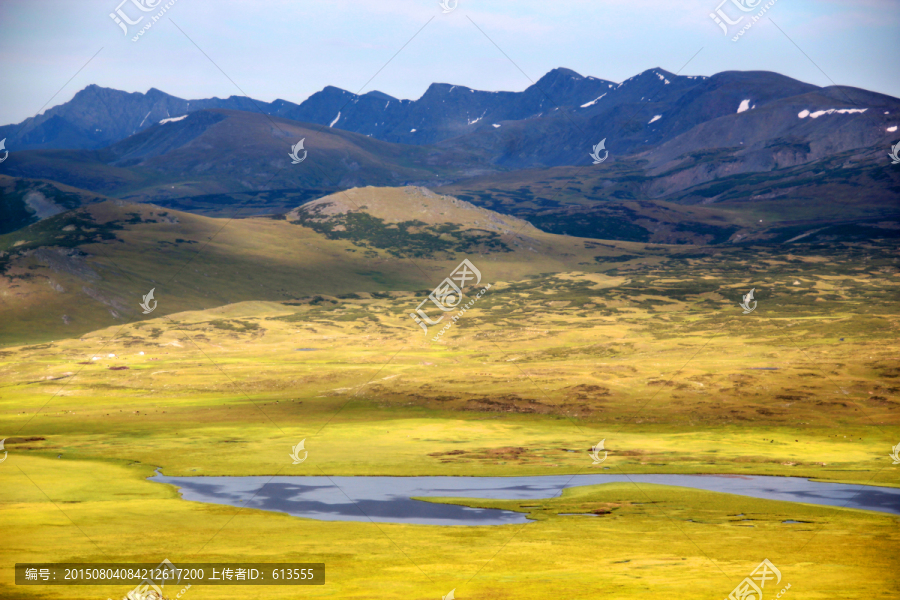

{"left": 0, "top": 200, "right": 900, "bottom": 600}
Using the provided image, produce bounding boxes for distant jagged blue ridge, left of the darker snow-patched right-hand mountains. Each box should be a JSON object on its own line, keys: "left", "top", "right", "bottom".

{"left": 0, "top": 69, "right": 614, "bottom": 150}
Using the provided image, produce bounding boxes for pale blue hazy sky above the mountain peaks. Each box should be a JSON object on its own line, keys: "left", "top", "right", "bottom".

{"left": 0, "top": 0, "right": 900, "bottom": 124}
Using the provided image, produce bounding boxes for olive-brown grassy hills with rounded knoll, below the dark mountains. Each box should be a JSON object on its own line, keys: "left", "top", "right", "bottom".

{"left": 0, "top": 188, "right": 661, "bottom": 345}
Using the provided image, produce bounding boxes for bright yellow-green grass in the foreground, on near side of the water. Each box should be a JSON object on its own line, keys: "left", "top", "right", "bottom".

{"left": 0, "top": 456, "right": 900, "bottom": 600}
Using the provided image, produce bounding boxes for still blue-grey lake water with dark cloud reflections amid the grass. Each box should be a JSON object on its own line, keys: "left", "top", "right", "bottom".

{"left": 150, "top": 474, "right": 900, "bottom": 525}
